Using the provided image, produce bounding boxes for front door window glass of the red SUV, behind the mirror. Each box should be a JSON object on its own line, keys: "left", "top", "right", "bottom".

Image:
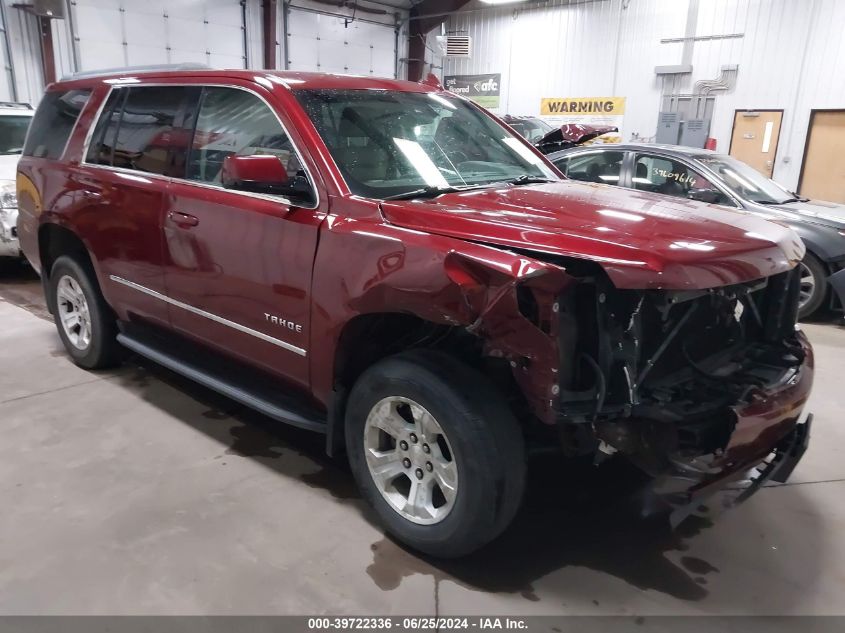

{"left": 186, "top": 87, "right": 305, "bottom": 186}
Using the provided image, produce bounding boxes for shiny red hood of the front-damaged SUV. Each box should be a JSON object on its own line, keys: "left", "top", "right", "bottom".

{"left": 382, "top": 181, "right": 804, "bottom": 289}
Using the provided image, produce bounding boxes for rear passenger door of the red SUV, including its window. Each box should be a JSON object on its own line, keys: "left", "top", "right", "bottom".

{"left": 74, "top": 86, "right": 185, "bottom": 325}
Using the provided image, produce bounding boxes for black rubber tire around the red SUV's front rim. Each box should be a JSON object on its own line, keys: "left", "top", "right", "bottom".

{"left": 346, "top": 350, "right": 525, "bottom": 558}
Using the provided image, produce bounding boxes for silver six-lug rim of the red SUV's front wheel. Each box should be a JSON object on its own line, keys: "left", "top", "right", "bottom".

{"left": 364, "top": 396, "right": 458, "bottom": 525}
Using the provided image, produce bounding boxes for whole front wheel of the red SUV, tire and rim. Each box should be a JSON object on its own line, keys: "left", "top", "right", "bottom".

{"left": 346, "top": 350, "right": 525, "bottom": 558}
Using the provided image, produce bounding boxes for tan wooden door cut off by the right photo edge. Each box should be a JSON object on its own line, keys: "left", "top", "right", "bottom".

{"left": 799, "top": 110, "right": 845, "bottom": 203}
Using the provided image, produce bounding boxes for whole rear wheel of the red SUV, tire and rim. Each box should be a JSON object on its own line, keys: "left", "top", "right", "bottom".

{"left": 49, "top": 255, "right": 121, "bottom": 369}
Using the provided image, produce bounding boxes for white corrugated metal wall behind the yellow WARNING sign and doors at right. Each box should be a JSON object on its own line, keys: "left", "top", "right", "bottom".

{"left": 430, "top": 0, "right": 845, "bottom": 188}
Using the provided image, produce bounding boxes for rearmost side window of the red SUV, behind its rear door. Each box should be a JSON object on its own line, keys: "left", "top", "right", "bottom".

{"left": 23, "top": 90, "right": 91, "bottom": 159}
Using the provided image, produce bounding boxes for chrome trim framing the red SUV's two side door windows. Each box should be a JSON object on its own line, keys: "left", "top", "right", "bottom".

{"left": 77, "top": 81, "right": 321, "bottom": 210}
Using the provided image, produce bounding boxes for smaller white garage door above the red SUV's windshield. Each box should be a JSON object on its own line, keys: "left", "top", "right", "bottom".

{"left": 287, "top": 7, "right": 396, "bottom": 77}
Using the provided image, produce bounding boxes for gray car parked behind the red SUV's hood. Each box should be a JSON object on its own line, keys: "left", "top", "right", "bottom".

{"left": 548, "top": 143, "right": 845, "bottom": 317}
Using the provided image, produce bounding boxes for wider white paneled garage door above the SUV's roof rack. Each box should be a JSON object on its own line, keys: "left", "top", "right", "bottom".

{"left": 71, "top": 0, "right": 244, "bottom": 70}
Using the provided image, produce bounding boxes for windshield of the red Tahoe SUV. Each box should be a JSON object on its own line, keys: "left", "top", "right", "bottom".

{"left": 294, "top": 90, "right": 559, "bottom": 199}
